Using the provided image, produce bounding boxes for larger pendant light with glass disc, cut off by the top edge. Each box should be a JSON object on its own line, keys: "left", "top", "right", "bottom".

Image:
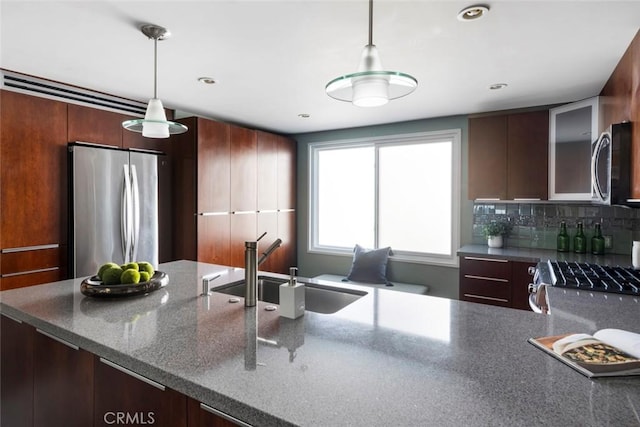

{"left": 325, "top": 0, "right": 418, "bottom": 107}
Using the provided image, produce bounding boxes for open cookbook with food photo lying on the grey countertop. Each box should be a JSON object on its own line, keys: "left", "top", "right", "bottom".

{"left": 528, "top": 329, "right": 640, "bottom": 378}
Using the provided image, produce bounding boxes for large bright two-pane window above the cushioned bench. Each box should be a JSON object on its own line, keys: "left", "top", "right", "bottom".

{"left": 309, "top": 130, "right": 460, "bottom": 265}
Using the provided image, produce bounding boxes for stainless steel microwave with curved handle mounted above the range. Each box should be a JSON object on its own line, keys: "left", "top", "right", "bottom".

{"left": 591, "top": 122, "right": 633, "bottom": 205}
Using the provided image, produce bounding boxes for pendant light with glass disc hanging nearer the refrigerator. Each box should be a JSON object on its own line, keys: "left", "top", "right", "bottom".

{"left": 122, "top": 25, "right": 188, "bottom": 138}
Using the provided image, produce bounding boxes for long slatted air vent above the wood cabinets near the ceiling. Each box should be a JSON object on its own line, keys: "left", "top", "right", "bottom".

{"left": 1, "top": 70, "right": 147, "bottom": 116}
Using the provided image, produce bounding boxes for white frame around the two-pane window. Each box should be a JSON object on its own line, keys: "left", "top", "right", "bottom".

{"left": 307, "top": 129, "right": 462, "bottom": 267}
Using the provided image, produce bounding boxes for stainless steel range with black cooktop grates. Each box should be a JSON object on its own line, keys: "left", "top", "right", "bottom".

{"left": 529, "top": 260, "right": 640, "bottom": 314}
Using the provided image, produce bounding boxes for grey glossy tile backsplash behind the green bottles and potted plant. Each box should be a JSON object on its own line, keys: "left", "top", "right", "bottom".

{"left": 473, "top": 202, "right": 640, "bottom": 254}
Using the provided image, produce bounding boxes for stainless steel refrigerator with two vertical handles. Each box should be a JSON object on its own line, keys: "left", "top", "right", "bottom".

{"left": 69, "top": 143, "right": 158, "bottom": 277}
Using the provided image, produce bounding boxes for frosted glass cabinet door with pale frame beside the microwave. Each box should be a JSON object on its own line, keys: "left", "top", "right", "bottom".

{"left": 549, "top": 97, "right": 602, "bottom": 200}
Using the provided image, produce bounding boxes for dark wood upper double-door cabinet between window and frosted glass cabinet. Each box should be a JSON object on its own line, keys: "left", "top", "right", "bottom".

{"left": 468, "top": 110, "right": 549, "bottom": 200}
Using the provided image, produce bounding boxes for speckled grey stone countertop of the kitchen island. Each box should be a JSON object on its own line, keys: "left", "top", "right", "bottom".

{"left": 0, "top": 261, "right": 640, "bottom": 426}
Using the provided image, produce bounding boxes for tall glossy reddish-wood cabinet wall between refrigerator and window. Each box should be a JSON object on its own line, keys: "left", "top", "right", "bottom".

{"left": 172, "top": 117, "right": 296, "bottom": 273}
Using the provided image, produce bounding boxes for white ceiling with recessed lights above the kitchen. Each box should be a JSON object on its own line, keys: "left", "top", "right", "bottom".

{"left": 0, "top": 0, "right": 640, "bottom": 134}
